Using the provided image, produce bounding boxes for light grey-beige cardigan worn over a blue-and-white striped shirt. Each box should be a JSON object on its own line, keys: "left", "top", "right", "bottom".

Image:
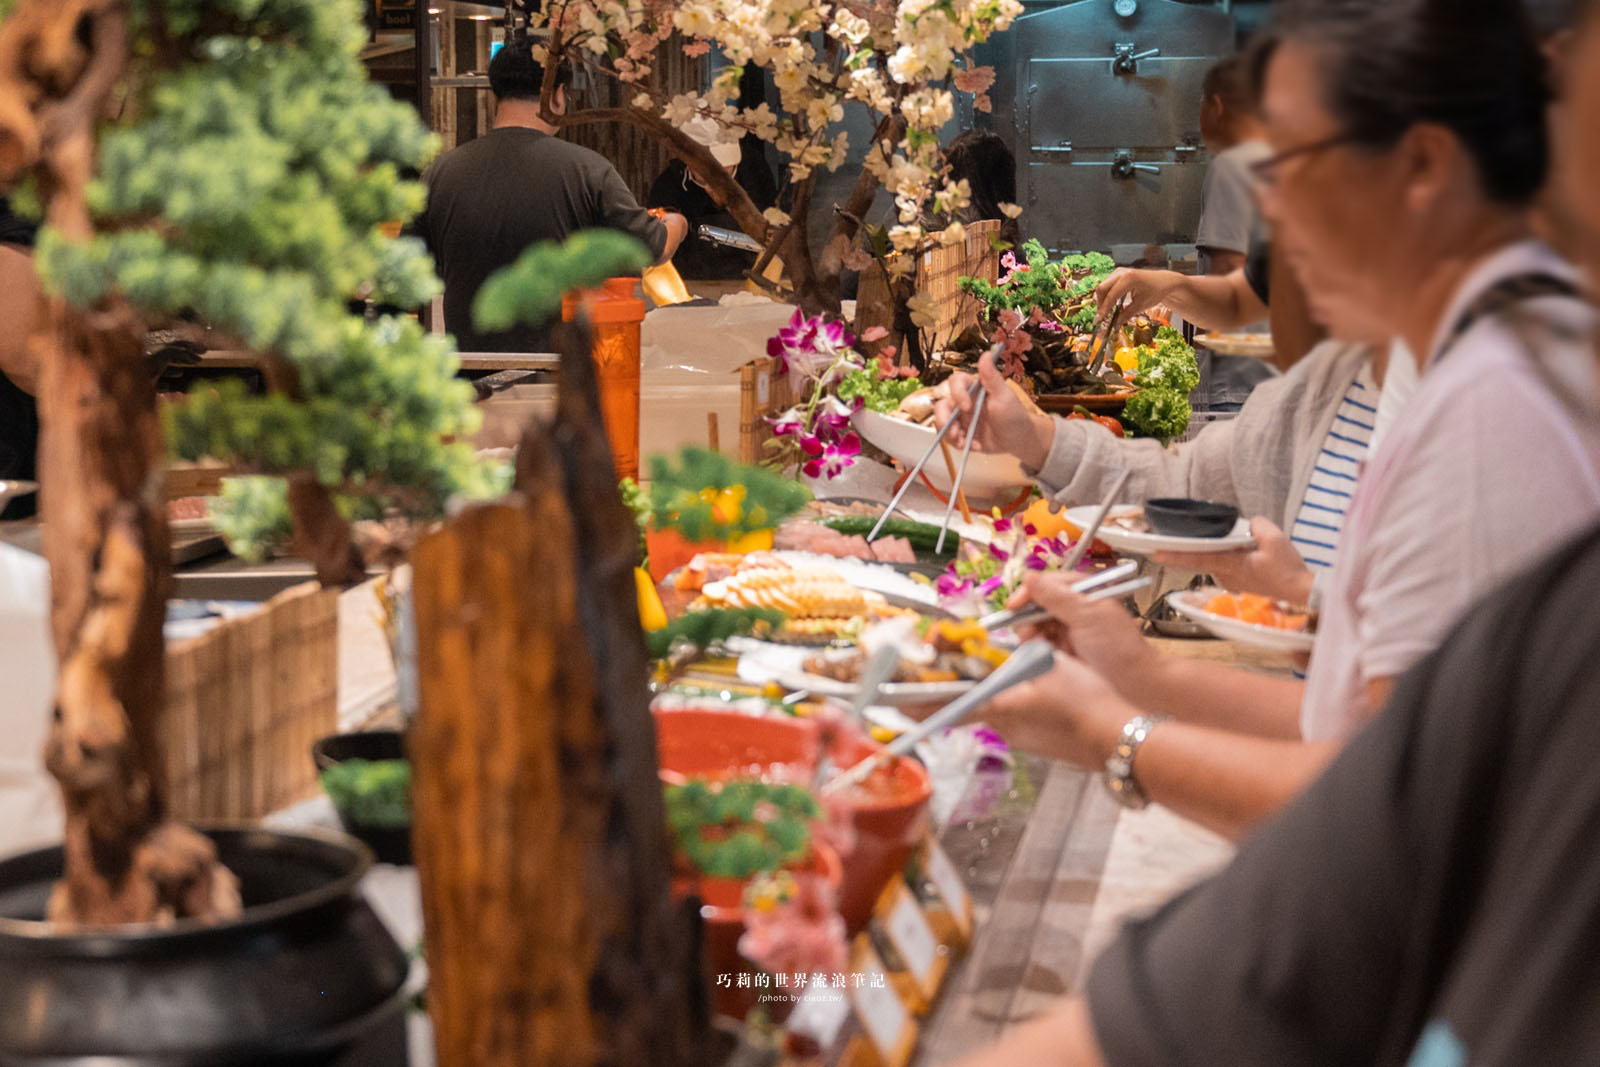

{"left": 1030, "top": 341, "right": 1368, "bottom": 530}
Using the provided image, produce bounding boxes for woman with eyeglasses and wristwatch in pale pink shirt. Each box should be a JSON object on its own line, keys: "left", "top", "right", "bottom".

{"left": 960, "top": 0, "right": 1600, "bottom": 835}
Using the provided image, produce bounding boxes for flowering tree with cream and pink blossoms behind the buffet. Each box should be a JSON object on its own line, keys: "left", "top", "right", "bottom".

{"left": 525, "top": 0, "right": 1022, "bottom": 315}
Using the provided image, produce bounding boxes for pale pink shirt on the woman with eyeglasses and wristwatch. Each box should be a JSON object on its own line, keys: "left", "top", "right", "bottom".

{"left": 1301, "top": 242, "right": 1600, "bottom": 741}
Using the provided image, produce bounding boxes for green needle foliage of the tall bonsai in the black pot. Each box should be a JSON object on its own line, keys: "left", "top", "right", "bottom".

{"left": 23, "top": 0, "right": 509, "bottom": 555}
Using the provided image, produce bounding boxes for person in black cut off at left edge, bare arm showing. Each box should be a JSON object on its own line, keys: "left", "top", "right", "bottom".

{"left": 0, "top": 197, "right": 38, "bottom": 518}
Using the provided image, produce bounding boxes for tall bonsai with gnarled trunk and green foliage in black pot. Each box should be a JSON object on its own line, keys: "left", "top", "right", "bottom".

{"left": 0, "top": 0, "right": 494, "bottom": 925}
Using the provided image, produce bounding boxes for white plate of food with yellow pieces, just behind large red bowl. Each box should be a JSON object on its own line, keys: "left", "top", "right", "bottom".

{"left": 778, "top": 619, "right": 1006, "bottom": 707}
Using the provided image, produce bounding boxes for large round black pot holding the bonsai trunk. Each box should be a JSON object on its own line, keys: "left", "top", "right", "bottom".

{"left": 0, "top": 829, "right": 408, "bottom": 1067}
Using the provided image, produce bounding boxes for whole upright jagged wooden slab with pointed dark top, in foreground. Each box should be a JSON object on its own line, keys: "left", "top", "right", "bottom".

{"left": 410, "top": 319, "right": 707, "bottom": 1067}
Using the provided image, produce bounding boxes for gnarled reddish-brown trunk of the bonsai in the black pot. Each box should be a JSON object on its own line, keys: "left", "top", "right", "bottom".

{"left": 0, "top": 0, "right": 238, "bottom": 926}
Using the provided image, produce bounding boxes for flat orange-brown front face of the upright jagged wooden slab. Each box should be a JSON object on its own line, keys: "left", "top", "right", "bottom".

{"left": 410, "top": 494, "right": 614, "bottom": 1067}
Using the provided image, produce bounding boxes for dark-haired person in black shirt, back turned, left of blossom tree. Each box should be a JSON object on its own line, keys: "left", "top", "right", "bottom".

{"left": 411, "top": 37, "right": 688, "bottom": 352}
